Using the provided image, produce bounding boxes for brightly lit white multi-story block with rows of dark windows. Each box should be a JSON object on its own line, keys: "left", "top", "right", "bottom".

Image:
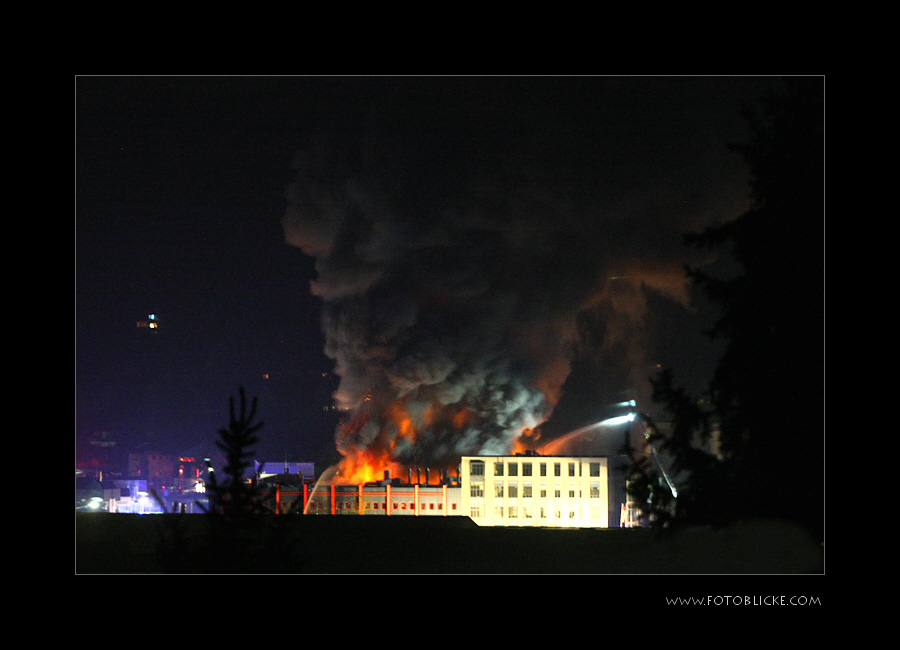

{"left": 460, "top": 455, "right": 628, "bottom": 528}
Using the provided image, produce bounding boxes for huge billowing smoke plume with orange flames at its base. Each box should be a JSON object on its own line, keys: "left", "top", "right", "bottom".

{"left": 284, "top": 79, "right": 760, "bottom": 476}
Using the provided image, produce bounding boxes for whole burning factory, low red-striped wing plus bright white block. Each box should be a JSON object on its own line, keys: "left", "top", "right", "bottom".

{"left": 277, "top": 453, "right": 635, "bottom": 528}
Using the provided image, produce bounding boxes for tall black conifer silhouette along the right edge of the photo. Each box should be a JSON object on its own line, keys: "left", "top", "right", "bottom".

{"left": 636, "top": 77, "right": 825, "bottom": 540}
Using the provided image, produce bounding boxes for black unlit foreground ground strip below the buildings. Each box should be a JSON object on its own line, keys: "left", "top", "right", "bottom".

{"left": 75, "top": 513, "right": 823, "bottom": 574}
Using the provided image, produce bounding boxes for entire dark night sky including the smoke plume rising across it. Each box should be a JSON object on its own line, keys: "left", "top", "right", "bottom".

{"left": 75, "top": 77, "right": 778, "bottom": 470}
